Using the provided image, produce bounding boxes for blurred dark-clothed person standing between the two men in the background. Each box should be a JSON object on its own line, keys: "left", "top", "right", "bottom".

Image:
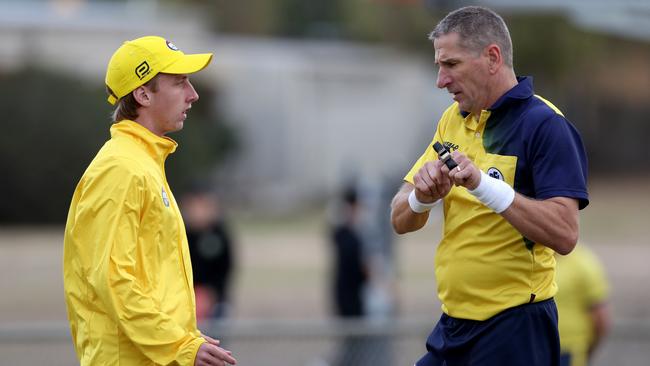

{"left": 332, "top": 187, "right": 368, "bottom": 317}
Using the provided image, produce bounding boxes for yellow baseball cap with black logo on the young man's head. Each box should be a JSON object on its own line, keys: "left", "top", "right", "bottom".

{"left": 106, "top": 36, "right": 212, "bottom": 105}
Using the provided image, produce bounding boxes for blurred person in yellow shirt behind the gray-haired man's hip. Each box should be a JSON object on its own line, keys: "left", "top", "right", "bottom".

{"left": 555, "top": 244, "right": 610, "bottom": 366}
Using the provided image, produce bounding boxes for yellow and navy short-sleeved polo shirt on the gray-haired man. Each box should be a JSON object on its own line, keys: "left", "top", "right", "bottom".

{"left": 404, "top": 77, "right": 589, "bottom": 320}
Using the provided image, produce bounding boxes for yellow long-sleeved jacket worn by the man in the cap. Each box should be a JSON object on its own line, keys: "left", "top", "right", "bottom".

{"left": 63, "top": 121, "right": 205, "bottom": 365}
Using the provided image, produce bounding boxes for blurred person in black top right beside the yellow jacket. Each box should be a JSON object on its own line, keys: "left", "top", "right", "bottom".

{"left": 182, "top": 187, "right": 234, "bottom": 321}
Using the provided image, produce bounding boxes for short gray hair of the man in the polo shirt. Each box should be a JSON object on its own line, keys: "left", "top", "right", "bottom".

{"left": 429, "top": 6, "right": 512, "bottom": 68}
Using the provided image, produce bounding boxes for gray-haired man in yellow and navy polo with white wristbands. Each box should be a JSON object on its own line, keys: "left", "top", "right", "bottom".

{"left": 392, "top": 7, "right": 588, "bottom": 366}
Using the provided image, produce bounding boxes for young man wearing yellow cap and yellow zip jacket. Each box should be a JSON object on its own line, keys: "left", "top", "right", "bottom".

{"left": 63, "top": 36, "right": 236, "bottom": 365}
